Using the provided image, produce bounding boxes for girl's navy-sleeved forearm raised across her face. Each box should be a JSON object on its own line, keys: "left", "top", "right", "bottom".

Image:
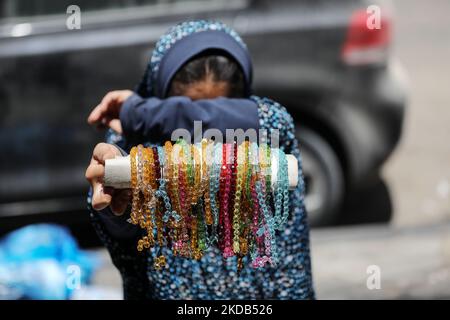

{"left": 119, "top": 94, "right": 259, "bottom": 145}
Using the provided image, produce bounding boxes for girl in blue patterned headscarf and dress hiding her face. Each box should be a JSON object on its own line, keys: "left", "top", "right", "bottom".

{"left": 86, "top": 21, "right": 314, "bottom": 299}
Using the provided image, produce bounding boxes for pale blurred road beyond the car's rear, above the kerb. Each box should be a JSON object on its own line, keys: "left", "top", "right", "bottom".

{"left": 383, "top": 0, "right": 450, "bottom": 226}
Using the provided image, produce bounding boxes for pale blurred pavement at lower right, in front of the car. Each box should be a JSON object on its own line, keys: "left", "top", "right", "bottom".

{"left": 311, "top": 223, "right": 450, "bottom": 299}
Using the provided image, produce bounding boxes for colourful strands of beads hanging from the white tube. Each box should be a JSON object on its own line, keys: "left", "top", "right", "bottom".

{"left": 126, "top": 139, "right": 289, "bottom": 272}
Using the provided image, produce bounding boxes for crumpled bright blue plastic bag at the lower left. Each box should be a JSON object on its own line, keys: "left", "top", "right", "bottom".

{"left": 0, "top": 224, "right": 99, "bottom": 299}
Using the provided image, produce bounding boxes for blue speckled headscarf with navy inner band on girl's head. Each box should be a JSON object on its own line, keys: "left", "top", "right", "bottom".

{"left": 136, "top": 20, "right": 252, "bottom": 98}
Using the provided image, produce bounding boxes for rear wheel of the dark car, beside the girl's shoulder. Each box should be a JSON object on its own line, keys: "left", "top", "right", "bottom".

{"left": 296, "top": 127, "right": 345, "bottom": 227}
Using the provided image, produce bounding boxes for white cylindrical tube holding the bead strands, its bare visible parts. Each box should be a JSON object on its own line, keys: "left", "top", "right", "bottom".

{"left": 103, "top": 152, "right": 298, "bottom": 190}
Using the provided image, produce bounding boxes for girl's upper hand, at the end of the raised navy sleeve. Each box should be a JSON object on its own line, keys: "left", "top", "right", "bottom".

{"left": 87, "top": 90, "right": 133, "bottom": 134}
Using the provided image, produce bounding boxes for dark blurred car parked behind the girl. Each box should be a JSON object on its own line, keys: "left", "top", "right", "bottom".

{"left": 0, "top": 0, "right": 405, "bottom": 234}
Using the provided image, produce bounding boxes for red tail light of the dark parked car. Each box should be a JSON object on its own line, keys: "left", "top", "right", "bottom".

{"left": 342, "top": 10, "right": 391, "bottom": 65}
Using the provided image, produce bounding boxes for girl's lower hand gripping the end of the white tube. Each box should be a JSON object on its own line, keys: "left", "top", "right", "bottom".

{"left": 86, "top": 143, "right": 131, "bottom": 215}
